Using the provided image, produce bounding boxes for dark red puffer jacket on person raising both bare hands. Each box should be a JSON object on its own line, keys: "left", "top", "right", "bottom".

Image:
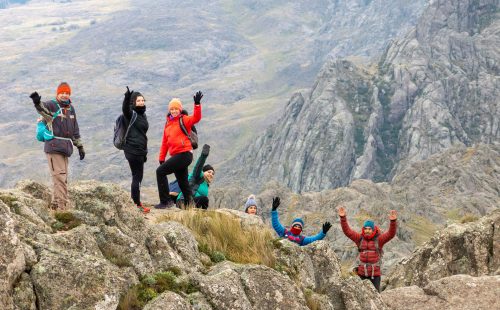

{"left": 340, "top": 216, "right": 397, "bottom": 276}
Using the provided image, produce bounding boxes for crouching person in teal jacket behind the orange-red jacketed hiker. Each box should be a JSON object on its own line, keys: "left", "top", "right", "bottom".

{"left": 177, "top": 144, "right": 215, "bottom": 210}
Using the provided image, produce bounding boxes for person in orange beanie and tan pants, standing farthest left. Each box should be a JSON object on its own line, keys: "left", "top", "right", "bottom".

{"left": 30, "top": 82, "right": 85, "bottom": 210}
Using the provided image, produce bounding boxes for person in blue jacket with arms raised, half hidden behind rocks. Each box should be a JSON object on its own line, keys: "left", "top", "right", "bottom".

{"left": 271, "top": 197, "right": 332, "bottom": 246}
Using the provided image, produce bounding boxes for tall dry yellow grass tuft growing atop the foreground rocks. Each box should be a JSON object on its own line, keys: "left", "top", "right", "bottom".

{"left": 159, "top": 209, "right": 275, "bottom": 268}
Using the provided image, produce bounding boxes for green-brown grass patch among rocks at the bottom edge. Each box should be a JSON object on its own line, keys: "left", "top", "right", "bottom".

{"left": 117, "top": 271, "right": 198, "bottom": 310}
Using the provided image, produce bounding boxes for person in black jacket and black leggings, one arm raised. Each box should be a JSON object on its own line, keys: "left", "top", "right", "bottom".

{"left": 122, "top": 86, "right": 150, "bottom": 213}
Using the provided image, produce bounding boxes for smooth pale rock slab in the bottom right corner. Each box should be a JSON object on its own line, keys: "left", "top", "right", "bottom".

{"left": 381, "top": 275, "right": 500, "bottom": 310}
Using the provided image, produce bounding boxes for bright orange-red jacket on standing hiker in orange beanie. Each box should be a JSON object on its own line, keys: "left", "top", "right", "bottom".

{"left": 158, "top": 104, "right": 201, "bottom": 161}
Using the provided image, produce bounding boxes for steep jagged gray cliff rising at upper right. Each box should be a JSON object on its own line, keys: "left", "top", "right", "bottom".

{"left": 222, "top": 0, "right": 500, "bottom": 191}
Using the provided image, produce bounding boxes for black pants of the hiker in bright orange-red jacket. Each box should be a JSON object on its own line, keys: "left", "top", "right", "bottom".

{"left": 156, "top": 152, "right": 193, "bottom": 204}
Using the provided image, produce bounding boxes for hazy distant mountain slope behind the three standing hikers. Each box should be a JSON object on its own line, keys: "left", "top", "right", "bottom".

{"left": 0, "top": 0, "right": 426, "bottom": 185}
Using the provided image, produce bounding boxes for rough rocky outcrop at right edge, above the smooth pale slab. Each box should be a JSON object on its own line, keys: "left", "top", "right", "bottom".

{"left": 386, "top": 210, "right": 500, "bottom": 288}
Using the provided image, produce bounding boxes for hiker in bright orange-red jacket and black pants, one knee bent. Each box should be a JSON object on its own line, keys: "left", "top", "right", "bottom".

{"left": 155, "top": 91, "right": 203, "bottom": 209}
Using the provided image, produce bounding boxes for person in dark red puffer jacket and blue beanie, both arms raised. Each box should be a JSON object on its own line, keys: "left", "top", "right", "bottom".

{"left": 338, "top": 207, "right": 397, "bottom": 292}
